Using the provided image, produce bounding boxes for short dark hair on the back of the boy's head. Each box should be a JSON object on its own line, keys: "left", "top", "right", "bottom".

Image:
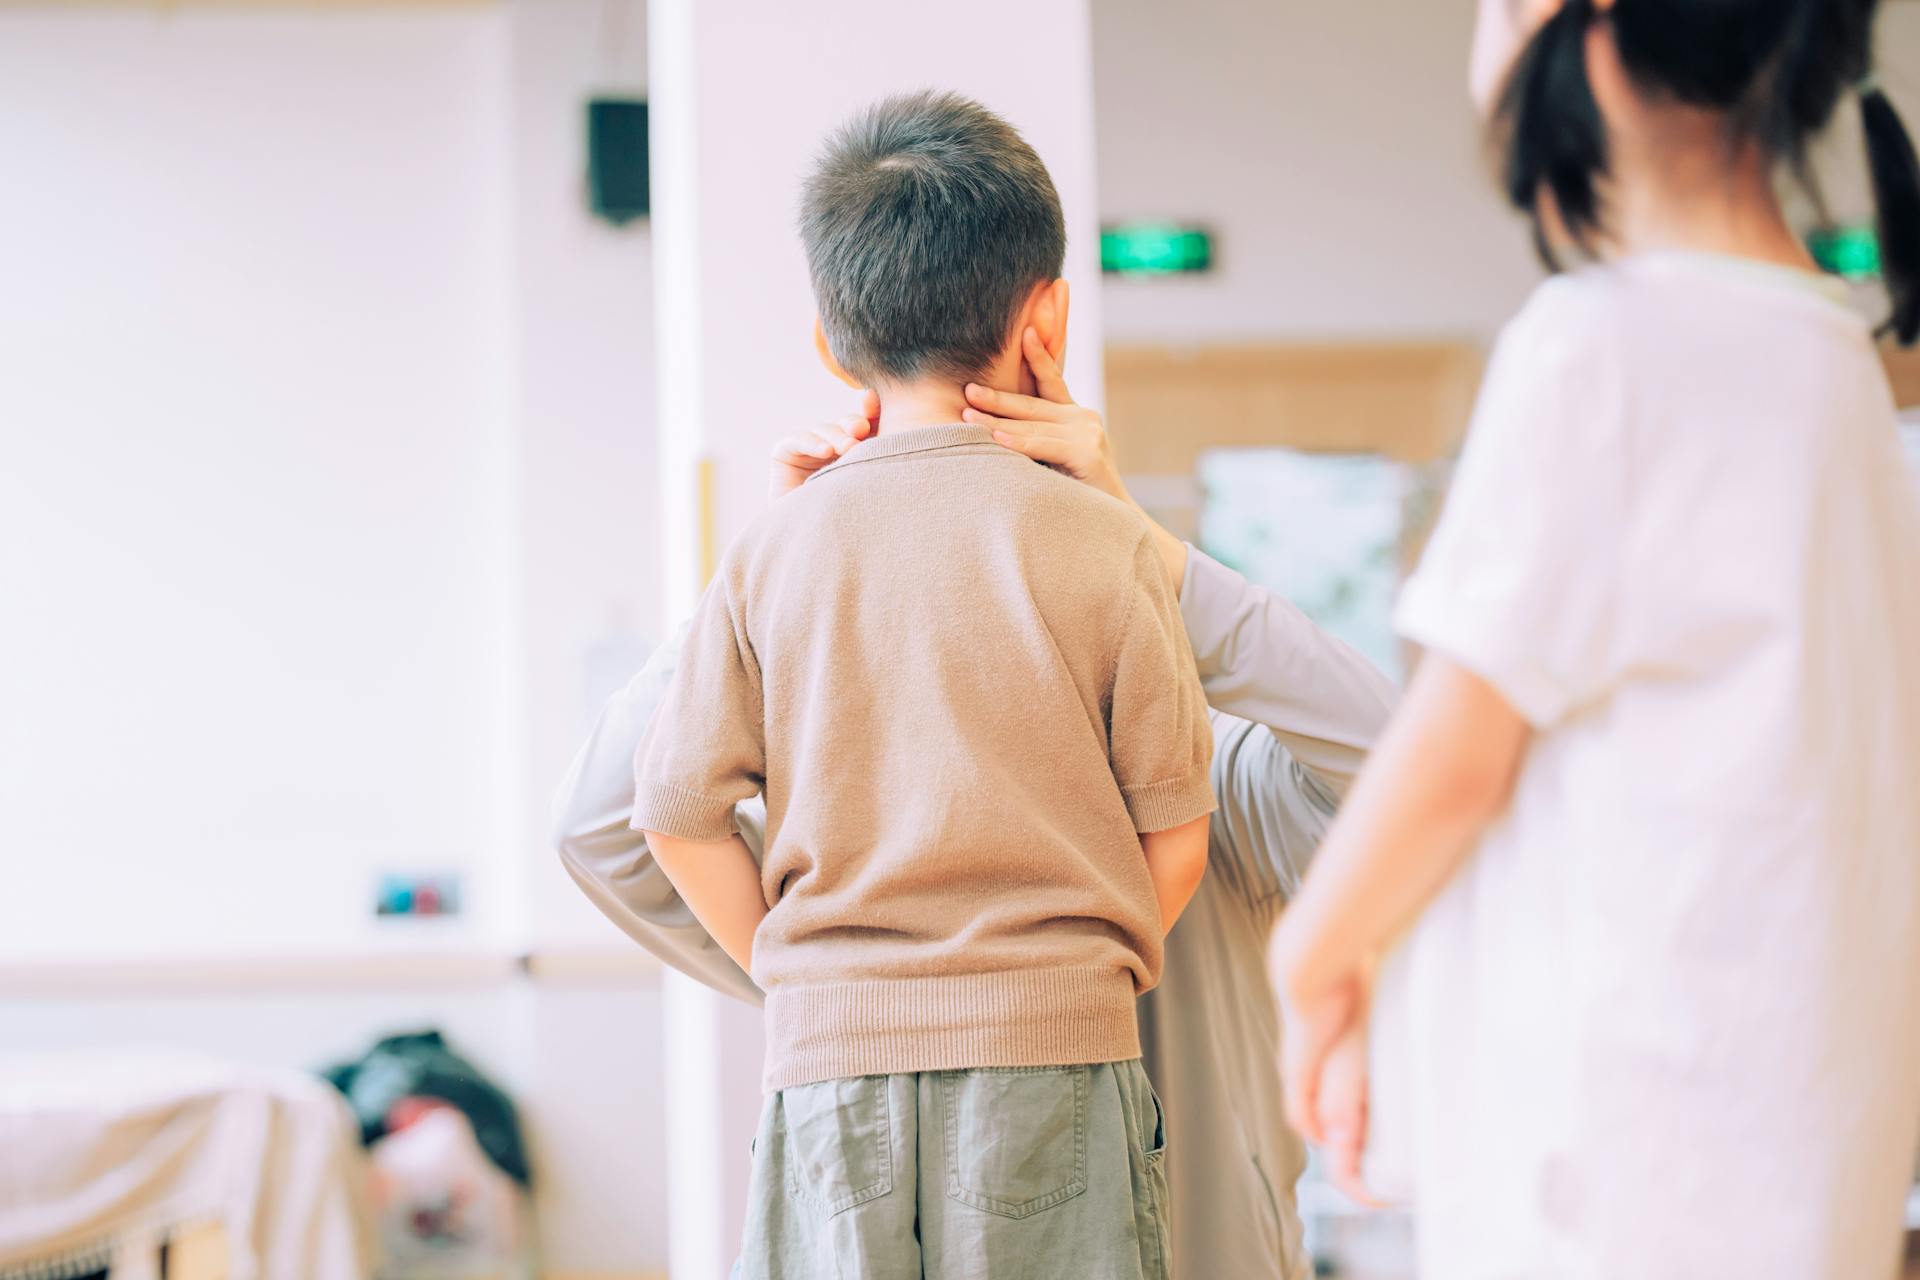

{"left": 801, "top": 90, "right": 1068, "bottom": 384}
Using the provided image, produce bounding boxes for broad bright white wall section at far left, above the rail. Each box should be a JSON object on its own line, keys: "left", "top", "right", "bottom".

{"left": 0, "top": 8, "right": 511, "bottom": 958}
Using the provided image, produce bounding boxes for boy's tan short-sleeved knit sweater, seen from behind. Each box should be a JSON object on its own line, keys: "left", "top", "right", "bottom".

{"left": 634, "top": 426, "right": 1213, "bottom": 1090}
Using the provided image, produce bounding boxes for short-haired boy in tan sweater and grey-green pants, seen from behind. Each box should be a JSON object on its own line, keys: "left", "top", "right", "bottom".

{"left": 634, "top": 94, "right": 1213, "bottom": 1280}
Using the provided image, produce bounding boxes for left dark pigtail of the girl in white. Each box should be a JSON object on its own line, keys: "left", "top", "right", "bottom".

{"left": 1496, "top": 0, "right": 1607, "bottom": 271}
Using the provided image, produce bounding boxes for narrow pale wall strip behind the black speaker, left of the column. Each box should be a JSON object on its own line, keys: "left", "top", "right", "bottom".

{"left": 509, "top": 0, "right": 670, "bottom": 948}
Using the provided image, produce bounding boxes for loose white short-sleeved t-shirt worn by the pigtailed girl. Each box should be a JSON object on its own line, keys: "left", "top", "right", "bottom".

{"left": 1375, "top": 253, "right": 1920, "bottom": 1280}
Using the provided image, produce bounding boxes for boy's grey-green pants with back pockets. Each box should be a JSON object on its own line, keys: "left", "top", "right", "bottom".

{"left": 735, "top": 1059, "right": 1169, "bottom": 1280}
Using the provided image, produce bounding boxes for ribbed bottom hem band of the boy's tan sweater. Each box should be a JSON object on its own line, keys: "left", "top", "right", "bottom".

{"left": 762, "top": 967, "right": 1140, "bottom": 1094}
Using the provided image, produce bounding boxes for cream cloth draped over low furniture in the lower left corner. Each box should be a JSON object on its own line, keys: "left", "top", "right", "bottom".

{"left": 0, "top": 1050, "right": 372, "bottom": 1280}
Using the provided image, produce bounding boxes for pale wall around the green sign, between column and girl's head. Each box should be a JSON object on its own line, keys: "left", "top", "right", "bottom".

{"left": 1094, "top": 0, "right": 1538, "bottom": 344}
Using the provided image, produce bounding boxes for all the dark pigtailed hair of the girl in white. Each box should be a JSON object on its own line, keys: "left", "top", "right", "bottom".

{"left": 1494, "top": 0, "right": 1920, "bottom": 344}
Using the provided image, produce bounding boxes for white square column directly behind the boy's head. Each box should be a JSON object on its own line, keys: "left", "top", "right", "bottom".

{"left": 647, "top": 0, "right": 1102, "bottom": 1280}
